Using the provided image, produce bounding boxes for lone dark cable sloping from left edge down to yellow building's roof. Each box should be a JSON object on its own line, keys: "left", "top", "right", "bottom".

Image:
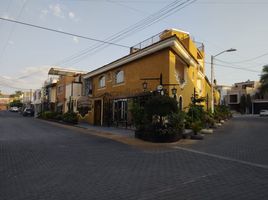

{"left": 0, "top": 17, "right": 130, "bottom": 48}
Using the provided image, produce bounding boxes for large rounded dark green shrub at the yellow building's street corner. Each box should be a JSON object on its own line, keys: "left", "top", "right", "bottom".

{"left": 131, "top": 95, "right": 185, "bottom": 142}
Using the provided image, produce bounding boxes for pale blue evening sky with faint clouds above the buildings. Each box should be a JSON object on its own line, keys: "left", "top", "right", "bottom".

{"left": 0, "top": 0, "right": 268, "bottom": 93}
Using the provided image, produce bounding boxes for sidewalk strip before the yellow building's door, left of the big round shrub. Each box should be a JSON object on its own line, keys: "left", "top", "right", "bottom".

{"left": 75, "top": 123, "right": 135, "bottom": 138}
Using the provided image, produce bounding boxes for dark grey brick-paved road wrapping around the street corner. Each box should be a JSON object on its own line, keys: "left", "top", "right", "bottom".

{"left": 0, "top": 112, "right": 268, "bottom": 200}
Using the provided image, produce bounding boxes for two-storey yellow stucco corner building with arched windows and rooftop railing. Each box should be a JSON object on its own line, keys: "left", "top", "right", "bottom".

{"left": 80, "top": 29, "right": 219, "bottom": 125}
